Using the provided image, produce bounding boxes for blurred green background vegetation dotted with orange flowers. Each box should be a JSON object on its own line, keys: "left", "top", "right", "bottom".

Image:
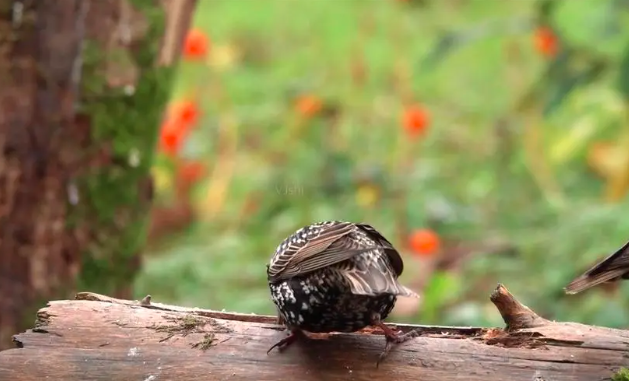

{"left": 135, "top": 0, "right": 629, "bottom": 327}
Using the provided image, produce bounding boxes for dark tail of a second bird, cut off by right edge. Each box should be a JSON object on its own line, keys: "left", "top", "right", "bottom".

{"left": 564, "top": 238, "right": 629, "bottom": 294}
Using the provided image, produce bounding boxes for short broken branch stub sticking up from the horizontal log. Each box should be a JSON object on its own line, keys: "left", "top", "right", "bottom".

{"left": 489, "top": 284, "right": 550, "bottom": 331}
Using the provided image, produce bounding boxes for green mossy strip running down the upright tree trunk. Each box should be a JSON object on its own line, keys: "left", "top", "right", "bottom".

{"left": 68, "top": 1, "right": 174, "bottom": 296}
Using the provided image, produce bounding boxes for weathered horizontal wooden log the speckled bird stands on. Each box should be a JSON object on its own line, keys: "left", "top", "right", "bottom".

{"left": 0, "top": 285, "right": 629, "bottom": 381}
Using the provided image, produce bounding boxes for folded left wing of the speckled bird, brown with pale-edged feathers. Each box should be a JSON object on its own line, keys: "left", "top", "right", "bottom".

{"left": 267, "top": 222, "right": 373, "bottom": 281}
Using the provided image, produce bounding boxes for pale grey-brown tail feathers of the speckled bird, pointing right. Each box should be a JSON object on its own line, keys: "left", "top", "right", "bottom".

{"left": 335, "top": 249, "right": 419, "bottom": 298}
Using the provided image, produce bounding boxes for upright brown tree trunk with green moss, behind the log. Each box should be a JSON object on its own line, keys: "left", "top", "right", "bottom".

{"left": 0, "top": 0, "right": 195, "bottom": 347}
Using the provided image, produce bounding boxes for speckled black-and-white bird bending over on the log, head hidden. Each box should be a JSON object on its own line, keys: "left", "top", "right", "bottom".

{"left": 267, "top": 220, "right": 419, "bottom": 367}
